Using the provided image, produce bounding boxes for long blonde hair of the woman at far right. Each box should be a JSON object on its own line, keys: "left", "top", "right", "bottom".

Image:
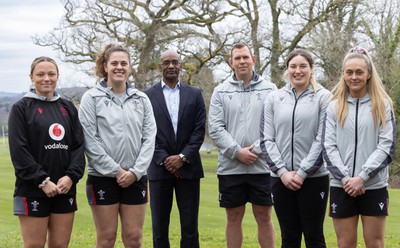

{"left": 332, "top": 46, "right": 394, "bottom": 127}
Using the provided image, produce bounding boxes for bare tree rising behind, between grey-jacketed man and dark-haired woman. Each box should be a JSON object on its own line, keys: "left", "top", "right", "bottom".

{"left": 223, "top": 0, "right": 358, "bottom": 85}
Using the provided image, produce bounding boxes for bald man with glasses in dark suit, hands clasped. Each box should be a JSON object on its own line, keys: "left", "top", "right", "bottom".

{"left": 144, "top": 50, "right": 206, "bottom": 248}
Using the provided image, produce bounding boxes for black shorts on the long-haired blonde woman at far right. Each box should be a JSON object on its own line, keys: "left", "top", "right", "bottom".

{"left": 329, "top": 187, "right": 389, "bottom": 218}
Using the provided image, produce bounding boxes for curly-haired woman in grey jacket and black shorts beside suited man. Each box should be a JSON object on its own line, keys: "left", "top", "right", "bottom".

{"left": 79, "top": 44, "right": 157, "bottom": 247}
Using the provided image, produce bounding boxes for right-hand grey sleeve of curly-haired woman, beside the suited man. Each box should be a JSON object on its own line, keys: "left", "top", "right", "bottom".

{"left": 129, "top": 95, "right": 157, "bottom": 180}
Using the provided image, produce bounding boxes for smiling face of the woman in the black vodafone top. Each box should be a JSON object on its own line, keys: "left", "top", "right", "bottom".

{"left": 29, "top": 61, "right": 58, "bottom": 99}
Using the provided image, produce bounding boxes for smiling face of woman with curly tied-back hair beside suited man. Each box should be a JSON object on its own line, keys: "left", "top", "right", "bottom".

{"left": 104, "top": 51, "right": 131, "bottom": 87}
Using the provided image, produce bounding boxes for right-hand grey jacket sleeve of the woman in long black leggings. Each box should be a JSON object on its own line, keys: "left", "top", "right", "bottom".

{"left": 297, "top": 90, "right": 332, "bottom": 178}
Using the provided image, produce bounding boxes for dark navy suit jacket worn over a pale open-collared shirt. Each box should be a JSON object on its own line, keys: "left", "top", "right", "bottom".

{"left": 144, "top": 82, "right": 206, "bottom": 180}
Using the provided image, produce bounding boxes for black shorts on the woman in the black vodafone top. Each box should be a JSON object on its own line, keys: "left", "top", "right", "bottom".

{"left": 14, "top": 195, "right": 78, "bottom": 217}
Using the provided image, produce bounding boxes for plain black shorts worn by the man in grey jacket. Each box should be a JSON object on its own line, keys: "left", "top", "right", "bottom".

{"left": 218, "top": 174, "right": 272, "bottom": 208}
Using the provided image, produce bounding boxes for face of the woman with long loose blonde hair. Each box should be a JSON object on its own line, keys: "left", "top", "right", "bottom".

{"left": 343, "top": 58, "right": 371, "bottom": 98}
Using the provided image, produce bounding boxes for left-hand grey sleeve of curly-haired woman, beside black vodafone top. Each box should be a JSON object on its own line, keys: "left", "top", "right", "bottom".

{"left": 79, "top": 91, "right": 121, "bottom": 177}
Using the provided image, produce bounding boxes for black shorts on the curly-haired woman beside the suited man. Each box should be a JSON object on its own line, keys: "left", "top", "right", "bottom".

{"left": 86, "top": 175, "right": 148, "bottom": 205}
